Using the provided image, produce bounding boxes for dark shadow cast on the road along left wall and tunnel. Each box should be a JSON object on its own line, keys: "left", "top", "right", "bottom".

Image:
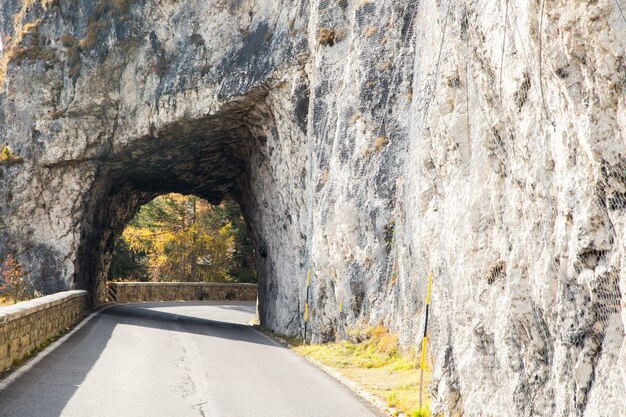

{"left": 0, "top": 303, "right": 283, "bottom": 417}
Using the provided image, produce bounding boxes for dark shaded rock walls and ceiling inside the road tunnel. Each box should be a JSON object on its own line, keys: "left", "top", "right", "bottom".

{"left": 72, "top": 100, "right": 282, "bottom": 324}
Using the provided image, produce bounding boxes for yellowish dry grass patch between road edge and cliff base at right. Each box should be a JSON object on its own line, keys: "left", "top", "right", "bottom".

{"left": 294, "top": 326, "right": 431, "bottom": 417}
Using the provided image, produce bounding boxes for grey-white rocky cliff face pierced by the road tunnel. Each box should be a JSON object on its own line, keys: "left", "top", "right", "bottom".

{"left": 0, "top": 0, "right": 626, "bottom": 416}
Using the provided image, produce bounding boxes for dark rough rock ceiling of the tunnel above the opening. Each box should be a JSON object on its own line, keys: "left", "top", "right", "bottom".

{"left": 106, "top": 118, "right": 256, "bottom": 203}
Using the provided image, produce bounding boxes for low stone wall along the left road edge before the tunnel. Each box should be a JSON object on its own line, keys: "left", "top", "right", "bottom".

{"left": 0, "top": 290, "right": 87, "bottom": 372}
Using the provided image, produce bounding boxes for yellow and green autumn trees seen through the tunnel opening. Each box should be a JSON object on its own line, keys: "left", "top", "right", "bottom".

{"left": 109, "top": 194, "right": 257, "bottom": 282}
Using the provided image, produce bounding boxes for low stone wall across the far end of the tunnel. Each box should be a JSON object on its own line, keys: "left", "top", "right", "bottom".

{"left": 107, "top": 282, "right": 257, "bottom": 303}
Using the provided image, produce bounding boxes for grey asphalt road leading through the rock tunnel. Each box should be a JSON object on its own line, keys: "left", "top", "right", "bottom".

{"left": 0, "top": 302, "right": 379, "bottom": 417}
